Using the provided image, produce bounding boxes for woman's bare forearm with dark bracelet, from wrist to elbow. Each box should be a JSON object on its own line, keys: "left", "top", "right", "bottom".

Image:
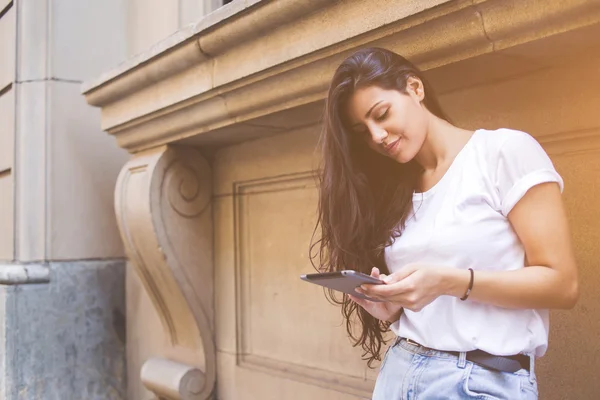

{"left": 442, "top": 266, "right": 578, "bottom": 309}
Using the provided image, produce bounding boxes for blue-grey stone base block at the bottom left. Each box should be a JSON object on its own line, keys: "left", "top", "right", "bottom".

{"left": 0, "top": 260, "right": 127, "bottom": 400}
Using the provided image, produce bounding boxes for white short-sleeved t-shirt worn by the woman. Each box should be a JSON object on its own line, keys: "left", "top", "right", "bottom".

{"left": 385, "top": 129, "right": 563, "bottom": 357}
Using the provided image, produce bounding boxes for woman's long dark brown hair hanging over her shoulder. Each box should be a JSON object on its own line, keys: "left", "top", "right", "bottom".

{"left": 310, "top": 48, "right": 447, "bottom": 367}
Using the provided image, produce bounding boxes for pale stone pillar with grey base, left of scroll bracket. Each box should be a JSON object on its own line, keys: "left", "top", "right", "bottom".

{"left": 0, "top": 0, "right": 127, "bottom": 400}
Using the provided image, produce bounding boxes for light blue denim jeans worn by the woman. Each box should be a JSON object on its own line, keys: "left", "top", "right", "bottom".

{"left": 373, "top": 339, "right": 538, "bottom": 400}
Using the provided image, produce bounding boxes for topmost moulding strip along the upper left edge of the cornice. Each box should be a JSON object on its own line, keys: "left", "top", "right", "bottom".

{"left": 82, "top": 0, "right": 331, "bottom": 106}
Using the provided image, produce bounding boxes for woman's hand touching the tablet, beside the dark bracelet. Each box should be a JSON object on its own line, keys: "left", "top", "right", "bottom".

{"left": 357, "top": 264, "right": 458, "bottom": 311}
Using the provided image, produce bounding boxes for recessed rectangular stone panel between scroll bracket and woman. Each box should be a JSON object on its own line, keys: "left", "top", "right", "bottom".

{"left": 235, "top": 172, "right": 372, "bottom": 395}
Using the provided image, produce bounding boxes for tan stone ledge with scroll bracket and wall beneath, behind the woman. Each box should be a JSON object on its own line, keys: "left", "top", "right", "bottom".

{"left": 84, "top": 0, "right": 600, "bottom": 400}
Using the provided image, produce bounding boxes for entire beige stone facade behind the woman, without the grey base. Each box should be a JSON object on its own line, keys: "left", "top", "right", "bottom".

{"left": 0, "top": 0, "right": 600, "bottom": 400}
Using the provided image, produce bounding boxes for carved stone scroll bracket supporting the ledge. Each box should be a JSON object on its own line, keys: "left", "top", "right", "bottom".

{"left": 115, "top": 146, "right": 216, "bottom": 400}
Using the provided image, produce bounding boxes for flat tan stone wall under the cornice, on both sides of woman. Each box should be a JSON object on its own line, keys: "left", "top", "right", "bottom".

{"left": 179, "top": 54, "right": 600, "bottom": 400}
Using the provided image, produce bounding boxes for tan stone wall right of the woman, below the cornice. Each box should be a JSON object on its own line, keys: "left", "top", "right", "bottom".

{"left": 441, "top": 54, "right": 600, "bottom": 400}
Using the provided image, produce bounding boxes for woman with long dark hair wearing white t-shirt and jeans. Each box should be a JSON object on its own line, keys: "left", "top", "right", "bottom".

{"left": 313, "top": 48, "right": 578, "bottom": 400}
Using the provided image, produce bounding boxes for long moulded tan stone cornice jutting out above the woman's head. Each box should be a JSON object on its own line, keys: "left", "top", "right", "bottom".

{"left": 84, "top": 0, "right": 600, "bottom": 152}
